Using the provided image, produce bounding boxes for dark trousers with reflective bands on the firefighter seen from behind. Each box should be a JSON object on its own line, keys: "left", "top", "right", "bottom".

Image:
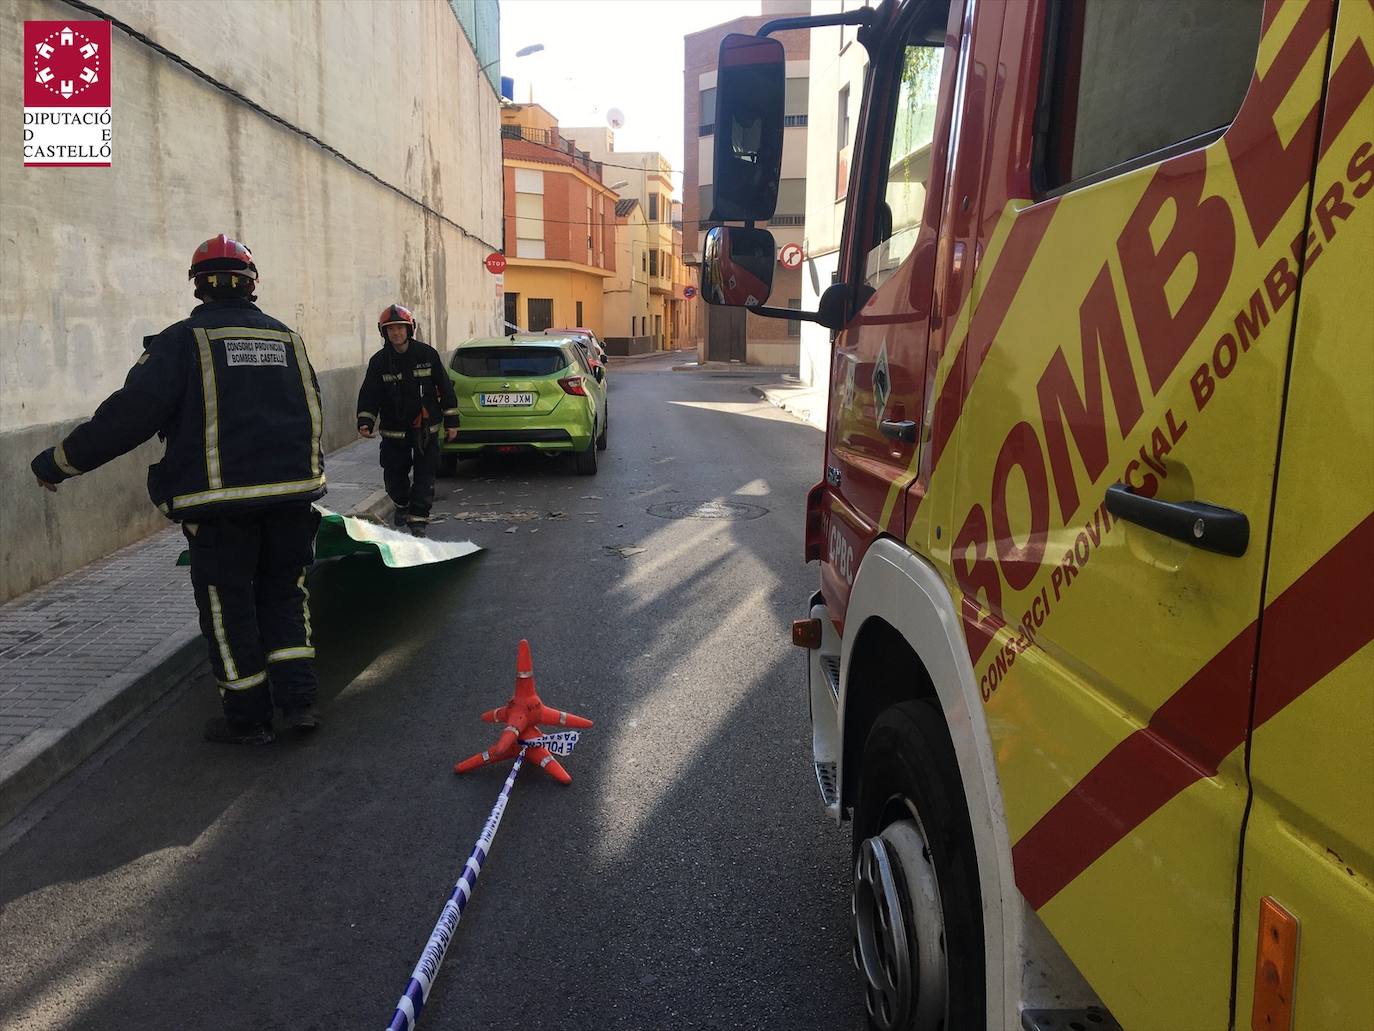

{"left": 181, "top": 505, "right": 319, "bottom": 723}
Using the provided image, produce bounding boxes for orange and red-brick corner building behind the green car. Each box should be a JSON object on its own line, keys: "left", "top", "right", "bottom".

{"left": 502, "top": 103, "right": 618, "bottom": 335}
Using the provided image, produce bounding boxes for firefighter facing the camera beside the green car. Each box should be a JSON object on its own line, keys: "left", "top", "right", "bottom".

{"left": 357, "top": 304, "right": 458, "bottom": 537}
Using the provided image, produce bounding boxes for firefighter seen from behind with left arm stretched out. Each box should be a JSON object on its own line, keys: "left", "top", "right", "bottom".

{"left": 32, "top": 234, "right": 324, "bottom": 744}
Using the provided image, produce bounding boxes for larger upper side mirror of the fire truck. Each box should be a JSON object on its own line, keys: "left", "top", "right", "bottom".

{"left": 709, "top": 33, "right": 787, "bottom": 221}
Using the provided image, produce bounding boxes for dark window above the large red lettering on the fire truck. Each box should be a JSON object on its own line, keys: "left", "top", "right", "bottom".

{"left": 1036, "top": 0, "right": 1263, "bottom": 190}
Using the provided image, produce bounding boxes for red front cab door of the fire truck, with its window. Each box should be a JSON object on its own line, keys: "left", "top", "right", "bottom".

{"left": 822, "top": 3, "right": 963, "bottom": 610}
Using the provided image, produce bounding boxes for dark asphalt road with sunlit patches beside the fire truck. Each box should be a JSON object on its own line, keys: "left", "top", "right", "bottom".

{"left": 0, "top": 360, "right": 861, "bottom": 1031}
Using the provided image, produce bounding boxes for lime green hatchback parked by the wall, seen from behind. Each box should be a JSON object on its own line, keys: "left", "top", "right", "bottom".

{"left": 442, "top": 335, "right": 606, "bottom": 476}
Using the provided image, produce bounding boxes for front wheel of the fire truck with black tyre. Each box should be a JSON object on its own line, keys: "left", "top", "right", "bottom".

{"left": 853, "top": 701, "right": 987, "bottom": 1031}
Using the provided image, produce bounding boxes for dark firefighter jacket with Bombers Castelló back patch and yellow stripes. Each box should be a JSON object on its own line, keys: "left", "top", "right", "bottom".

{"left": 32, "top": 300, "right": 324, "bottom": 521}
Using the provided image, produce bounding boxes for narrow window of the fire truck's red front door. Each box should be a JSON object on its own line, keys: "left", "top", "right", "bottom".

{"left": 864, "top": 24, "right": 945, "bottom": 290}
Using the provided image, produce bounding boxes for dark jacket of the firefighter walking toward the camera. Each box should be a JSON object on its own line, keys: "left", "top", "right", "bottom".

{"left": 357, "top": 340, "right": 458, "bottom": 440}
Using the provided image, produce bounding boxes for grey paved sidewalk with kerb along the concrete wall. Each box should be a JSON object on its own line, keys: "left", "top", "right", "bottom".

{"left": 0, "top": 441, "right": 382, "bottom": 826}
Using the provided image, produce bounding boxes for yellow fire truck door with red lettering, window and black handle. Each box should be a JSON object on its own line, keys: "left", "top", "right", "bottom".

{"left": 945, "top": 1, "right": 1331, "bottom": 1027}
